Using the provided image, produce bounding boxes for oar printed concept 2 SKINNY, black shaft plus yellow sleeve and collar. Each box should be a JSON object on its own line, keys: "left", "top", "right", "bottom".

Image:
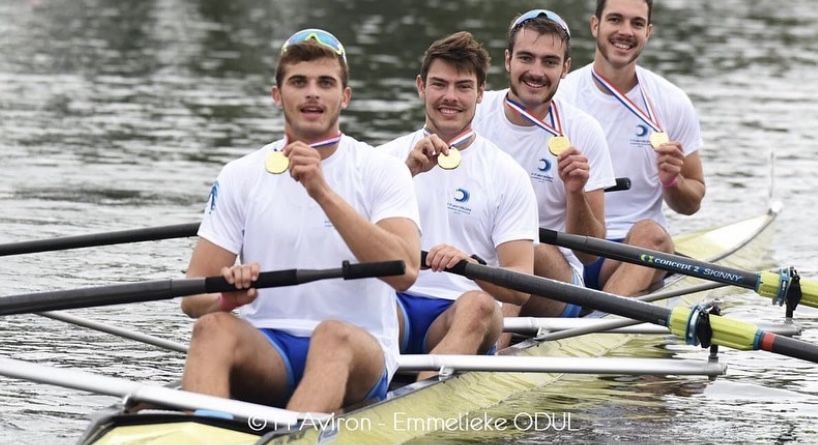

{"left": 540, "top": 228, "right": 818, "bottom": 309}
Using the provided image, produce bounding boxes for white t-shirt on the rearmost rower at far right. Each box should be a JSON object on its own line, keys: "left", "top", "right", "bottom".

{"left": 557, "top": 64, "right": 702, "bottom": 239}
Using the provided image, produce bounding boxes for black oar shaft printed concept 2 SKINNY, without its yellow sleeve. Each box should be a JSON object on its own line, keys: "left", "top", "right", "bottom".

{"left": 540, "top": 228, "right": 758, "bottom": 290}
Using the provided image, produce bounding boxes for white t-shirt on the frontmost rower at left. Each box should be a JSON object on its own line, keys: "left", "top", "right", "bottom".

{"left": 199, "top": 136, "right": 419, "bottom": 376}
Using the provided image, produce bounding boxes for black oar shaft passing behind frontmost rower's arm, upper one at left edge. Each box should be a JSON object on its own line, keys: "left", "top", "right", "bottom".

{"left": 0, "top": 223, "right": 199, "bottom": 256}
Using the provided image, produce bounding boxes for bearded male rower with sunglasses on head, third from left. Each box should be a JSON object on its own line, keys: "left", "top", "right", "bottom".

{"left": 474, "top": 9, "right": 615, "bottom": 317}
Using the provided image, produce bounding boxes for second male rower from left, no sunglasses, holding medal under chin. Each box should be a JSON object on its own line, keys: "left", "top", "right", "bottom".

{"left": 380, "top": 32, "right": 537, "bottom": 379}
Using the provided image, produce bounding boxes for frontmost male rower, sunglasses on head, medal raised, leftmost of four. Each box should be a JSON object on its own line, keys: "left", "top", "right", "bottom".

{"left": 182, "top": 29, "right": 420, "bottom": 412}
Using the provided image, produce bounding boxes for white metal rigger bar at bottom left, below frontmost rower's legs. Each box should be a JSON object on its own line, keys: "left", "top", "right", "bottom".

{"left": 0, "top": 357, "right": 327, "bottom": 427}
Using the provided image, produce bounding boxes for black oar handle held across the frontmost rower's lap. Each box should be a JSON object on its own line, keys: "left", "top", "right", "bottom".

{"left": 205, "top": 261, "right": 406, "bottom": 292}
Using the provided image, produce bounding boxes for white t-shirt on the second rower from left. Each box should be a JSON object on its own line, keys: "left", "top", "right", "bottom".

{"left": 378, "top": 130, "right": 538, "bottom": 300}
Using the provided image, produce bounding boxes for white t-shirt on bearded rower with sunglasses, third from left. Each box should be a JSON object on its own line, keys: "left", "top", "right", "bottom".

{"left": 472, "top": 89, "right": 616, "bottom": 271}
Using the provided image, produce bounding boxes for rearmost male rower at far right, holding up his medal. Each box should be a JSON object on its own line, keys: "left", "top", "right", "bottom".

{"left": 559, "top": 0, "right": 705, "bottom": 295}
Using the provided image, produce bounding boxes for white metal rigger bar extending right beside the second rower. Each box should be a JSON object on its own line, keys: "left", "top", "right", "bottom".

{"left": 398, "top": 354, "right": 727, "bottom": 376}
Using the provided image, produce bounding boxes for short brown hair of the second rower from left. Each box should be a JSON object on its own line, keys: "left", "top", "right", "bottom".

{"left": 420, "top": 31, "right": 491, "bottom": 86}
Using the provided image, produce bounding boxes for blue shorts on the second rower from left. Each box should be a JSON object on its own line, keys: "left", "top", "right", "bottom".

{"left": 397, "top": 292, "right": 497, "bottom": 355}
